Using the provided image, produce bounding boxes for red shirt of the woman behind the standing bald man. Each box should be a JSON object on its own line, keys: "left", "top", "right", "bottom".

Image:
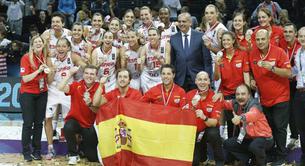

{"left": 251, "top": 25, "right": 284, "bottom": 47}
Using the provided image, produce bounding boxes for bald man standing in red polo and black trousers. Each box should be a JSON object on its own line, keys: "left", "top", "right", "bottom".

{"left": 249, "top": 29, "right": 291, "bottom": 165}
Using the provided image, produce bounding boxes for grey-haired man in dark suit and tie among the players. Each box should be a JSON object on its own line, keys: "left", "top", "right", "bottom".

{"left": 170, "top": 13, "right": 212, "bottom": 91}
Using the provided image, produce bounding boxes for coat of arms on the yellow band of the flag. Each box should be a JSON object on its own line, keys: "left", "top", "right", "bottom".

{"left": 114, "top": 119, "right": 132, "bottom": 149}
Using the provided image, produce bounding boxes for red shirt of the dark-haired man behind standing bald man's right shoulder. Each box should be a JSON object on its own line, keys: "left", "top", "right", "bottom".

{"left": 280, "top": 39, "right": 301, "bottom": 67}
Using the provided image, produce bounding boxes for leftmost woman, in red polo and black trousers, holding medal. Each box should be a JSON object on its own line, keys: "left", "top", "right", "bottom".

{"left": 20, "top": 36, "right": 50, "bottom": 161}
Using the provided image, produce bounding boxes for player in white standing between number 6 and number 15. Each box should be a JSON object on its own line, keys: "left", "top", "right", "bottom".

{"left": 121, "top": 31, "right": 141, "bottom": 90}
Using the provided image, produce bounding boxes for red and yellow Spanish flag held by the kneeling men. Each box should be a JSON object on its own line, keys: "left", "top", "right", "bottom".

{"left": 96, "top": 98, "right": 196, "bottom": 166}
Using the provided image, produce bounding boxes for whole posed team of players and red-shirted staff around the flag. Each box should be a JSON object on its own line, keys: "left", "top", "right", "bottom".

{"left": 20, "top": 4, "right": 305, "bottom": 165}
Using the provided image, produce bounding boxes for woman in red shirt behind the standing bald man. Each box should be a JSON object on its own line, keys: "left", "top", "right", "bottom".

{"left": 251, "top": 8, "right": 284, "bottom": 46}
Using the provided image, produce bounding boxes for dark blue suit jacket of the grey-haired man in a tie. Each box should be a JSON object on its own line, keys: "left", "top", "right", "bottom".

{"left": 170, "top": 29, "right": 212, "bottom": 86}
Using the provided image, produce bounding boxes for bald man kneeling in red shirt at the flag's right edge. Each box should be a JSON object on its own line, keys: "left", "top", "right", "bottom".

{"left": 187, "top": 71, "right": 224, "bottom": 166}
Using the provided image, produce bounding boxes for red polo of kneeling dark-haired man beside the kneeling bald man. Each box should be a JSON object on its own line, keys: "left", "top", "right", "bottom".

{"left": 141, "top": 84, "right": 186, "bottom": 107}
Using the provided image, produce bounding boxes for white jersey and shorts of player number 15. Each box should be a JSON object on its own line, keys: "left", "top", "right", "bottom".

{"left": 141, "top": 40, "right": 167, "bottom": 93}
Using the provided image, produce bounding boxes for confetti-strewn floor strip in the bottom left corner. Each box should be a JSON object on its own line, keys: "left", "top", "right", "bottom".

{"left": 0, "top": 154, "right": 101, "bottom": 166}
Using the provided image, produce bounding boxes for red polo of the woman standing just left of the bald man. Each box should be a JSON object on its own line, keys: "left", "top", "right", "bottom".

{"left": 219, "top": 49, "right": 249, "bottom": 96}
